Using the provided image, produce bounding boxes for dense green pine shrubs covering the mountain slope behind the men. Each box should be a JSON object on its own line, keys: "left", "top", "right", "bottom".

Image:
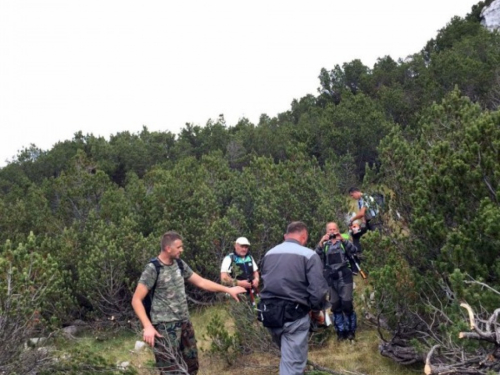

{"left": 0, "top": 1, "right": 500, "bottom": 374}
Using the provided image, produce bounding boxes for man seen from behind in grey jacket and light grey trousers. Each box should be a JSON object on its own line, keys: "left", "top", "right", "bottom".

{"left": 259, "top": 221, "right": 328, "bottom": 375}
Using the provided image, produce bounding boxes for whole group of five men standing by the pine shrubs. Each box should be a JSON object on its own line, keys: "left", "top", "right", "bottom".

{"left": 132, "top": 188, "right": 379, "bottom": 375}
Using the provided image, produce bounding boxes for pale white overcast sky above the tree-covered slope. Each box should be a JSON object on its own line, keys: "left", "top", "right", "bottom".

{"left": 0, "top": 0, "right": 478, "bottom": 167}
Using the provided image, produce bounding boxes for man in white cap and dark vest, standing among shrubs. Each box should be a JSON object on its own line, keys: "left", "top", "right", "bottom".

{"left": 220, "top": 237, "right": 259, "bottom": 290}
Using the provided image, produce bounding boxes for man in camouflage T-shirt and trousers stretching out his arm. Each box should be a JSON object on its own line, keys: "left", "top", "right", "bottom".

{"left": 132, "top": 231, "right": 245, "bottom": 375}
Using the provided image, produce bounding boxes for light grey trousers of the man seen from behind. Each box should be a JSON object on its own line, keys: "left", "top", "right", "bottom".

{"left": 268, "top": 314, "right": 310, "bottom": 375}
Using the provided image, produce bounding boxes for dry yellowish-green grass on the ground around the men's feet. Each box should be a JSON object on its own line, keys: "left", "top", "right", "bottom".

{"left": 60, "top": 280, "right": 422, "bottom": 375}
